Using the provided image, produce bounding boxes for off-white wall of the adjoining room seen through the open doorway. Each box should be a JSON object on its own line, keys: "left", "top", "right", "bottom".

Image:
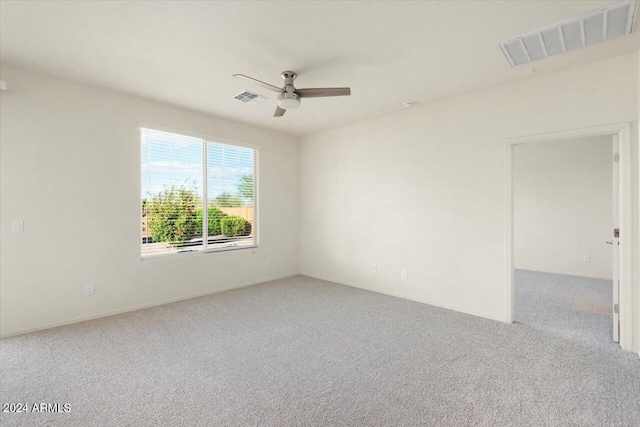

{"left": 514, "top": 136, "right": 613, "bottom": 280}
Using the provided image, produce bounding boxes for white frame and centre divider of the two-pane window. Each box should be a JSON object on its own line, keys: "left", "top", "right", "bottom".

{"left": 137, "top": 122, "right": 260, "bottom": 261}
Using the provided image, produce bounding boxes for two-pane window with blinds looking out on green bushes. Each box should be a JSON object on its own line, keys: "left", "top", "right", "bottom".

{"left": 141, "top": 128, "right": 257, "bottom": 258}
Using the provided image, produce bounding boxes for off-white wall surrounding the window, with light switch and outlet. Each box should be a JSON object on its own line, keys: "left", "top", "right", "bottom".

{"left": 0, "top": 64, "right": 298, "bottom": 336}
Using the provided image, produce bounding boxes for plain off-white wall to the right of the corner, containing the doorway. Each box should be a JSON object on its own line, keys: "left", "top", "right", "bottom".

{"left": 300, "top": 54, "right": 638, "bottom": 328}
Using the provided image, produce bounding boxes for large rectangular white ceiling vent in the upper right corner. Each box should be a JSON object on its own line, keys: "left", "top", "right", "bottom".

{"left": 500, "top": 0, "right": 636, "bottom": 67}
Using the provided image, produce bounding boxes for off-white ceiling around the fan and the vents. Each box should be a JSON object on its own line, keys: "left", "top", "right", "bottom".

{"left": 0, "top": 0, "right": 640, "bottom": 135}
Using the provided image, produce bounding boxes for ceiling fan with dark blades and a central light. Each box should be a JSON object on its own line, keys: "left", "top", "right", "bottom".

{"left": 233, "top": 71, "right": 351, "bottom": 117}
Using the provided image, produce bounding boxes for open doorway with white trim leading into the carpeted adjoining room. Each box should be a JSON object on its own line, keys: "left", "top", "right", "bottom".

{"left": 507, "top": 123, "right": 632, "bottom": 350}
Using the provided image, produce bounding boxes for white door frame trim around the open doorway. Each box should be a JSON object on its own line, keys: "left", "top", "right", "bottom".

{"left": 505, "top": 122, "right": 635, "bottom": 351}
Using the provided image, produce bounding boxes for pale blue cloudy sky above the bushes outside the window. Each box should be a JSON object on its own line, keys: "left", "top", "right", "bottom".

{"left": 142, "top": 129, "right": 254, "bottom": 199}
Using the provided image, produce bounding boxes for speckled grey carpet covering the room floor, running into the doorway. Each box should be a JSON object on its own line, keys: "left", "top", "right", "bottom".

{"left": 0, "top": 272, "right": 640, "bottom": 426}
